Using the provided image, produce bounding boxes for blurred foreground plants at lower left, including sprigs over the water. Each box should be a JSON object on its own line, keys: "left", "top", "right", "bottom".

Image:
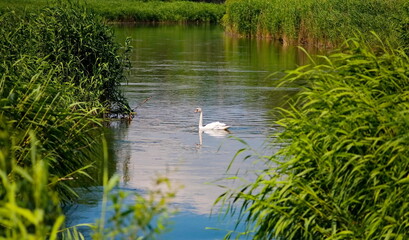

{"left": 0, "top": 123, "right": 174, "bottom": 240}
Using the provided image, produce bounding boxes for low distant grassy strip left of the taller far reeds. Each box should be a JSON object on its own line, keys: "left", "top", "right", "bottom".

{"left": 0, "top": 0, "right": 225, "bottom": 23}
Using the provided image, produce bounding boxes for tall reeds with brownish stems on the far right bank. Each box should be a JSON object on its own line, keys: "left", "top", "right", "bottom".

{"left": 223, "top": 0, "right": 409, "bottom": 45}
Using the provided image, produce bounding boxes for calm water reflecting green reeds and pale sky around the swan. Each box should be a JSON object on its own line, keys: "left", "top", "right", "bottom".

{"left": 65, "top": 25, "right": 306, "bottom": 239}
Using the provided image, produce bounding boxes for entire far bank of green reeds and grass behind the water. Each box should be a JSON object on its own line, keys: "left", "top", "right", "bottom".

{"left": 0, "top": 0, "right": 409, "bottom": 47}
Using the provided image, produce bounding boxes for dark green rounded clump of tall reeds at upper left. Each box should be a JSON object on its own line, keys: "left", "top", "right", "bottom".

{"left": 0, "top": 3, "right": 130, "bottom": 112}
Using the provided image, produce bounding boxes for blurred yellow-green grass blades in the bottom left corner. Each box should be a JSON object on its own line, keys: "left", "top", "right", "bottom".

{"left": 0, "top": 124, "right": 64, "bottom": 239}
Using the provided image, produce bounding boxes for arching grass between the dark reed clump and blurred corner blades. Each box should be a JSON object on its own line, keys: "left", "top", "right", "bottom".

{"left": 0, "top": 56, "right": 101, "bottom": 201}
